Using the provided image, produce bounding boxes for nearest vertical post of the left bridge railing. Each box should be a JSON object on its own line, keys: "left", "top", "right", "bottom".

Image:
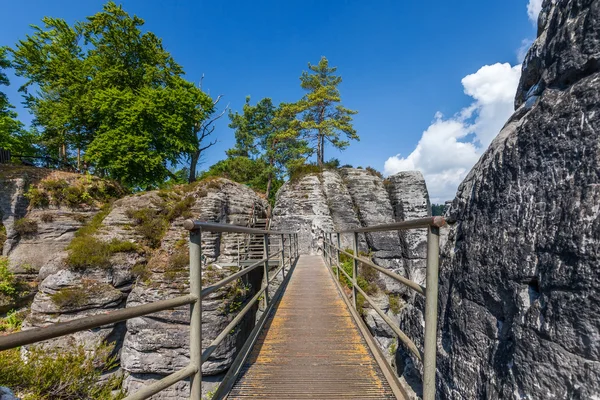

{"left": 189, "top": 229, "right": 202, "bottom": 400}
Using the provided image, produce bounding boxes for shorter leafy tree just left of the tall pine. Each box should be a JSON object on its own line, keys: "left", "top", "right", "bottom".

{"left": 227, "top": 97, "right": 310, "bottom": 198}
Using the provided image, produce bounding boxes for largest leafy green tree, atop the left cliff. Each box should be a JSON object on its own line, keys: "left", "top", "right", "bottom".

{"left": 13, "top": 1, "right": 212, "bottom": 188}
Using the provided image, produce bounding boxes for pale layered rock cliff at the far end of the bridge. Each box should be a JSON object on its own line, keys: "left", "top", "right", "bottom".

{"left": 273, "top": 168, "right": 431, "bottom": 384}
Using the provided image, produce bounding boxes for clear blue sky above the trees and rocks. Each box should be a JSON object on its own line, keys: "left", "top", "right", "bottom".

{"left": 0, "top": 0, "right": 539, "bottom": 200}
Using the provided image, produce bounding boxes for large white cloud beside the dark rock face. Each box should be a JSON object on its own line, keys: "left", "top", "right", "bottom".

{"left": 384, "top": 63, "right": 521, "bottom": 203}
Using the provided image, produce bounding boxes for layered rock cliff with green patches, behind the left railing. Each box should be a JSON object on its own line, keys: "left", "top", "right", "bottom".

{"left": 0, "top": 166, "right": 267, "bottom": 399}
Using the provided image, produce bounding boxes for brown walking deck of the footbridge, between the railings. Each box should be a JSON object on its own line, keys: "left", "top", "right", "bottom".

{"left": 227, "top": 256, "right": 396, "bottom": 399}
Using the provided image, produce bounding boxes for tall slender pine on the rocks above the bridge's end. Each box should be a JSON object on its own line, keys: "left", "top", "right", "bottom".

{"left": 289, "top": 57, "right": 359, "bottom": 167}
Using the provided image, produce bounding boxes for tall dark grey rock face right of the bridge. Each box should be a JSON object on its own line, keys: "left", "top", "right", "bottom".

{"left": 438, "top": 0, "right": 600, "bottom": 399}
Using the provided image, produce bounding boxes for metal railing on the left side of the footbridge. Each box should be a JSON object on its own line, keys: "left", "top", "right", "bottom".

{"left": 0, "top": 220, "right": 298, "bottom": 400}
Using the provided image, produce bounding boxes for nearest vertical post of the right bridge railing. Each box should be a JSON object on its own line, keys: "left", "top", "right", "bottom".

{"left": 423, "top": 226, "right": 440, "bottom": 400}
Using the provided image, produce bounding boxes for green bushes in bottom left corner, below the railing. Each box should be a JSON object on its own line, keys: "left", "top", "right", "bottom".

{"left": 0, "top": 345, "right": 125, "bottom": 400}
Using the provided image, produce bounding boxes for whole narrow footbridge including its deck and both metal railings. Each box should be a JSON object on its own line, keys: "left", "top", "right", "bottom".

{"left": 0, "top": 217, "right": 444, "bottom": 400}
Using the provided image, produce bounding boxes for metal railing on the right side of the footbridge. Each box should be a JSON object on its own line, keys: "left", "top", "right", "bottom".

{"left": 323, "top": 217, "right": 446, "bottom": 400}
